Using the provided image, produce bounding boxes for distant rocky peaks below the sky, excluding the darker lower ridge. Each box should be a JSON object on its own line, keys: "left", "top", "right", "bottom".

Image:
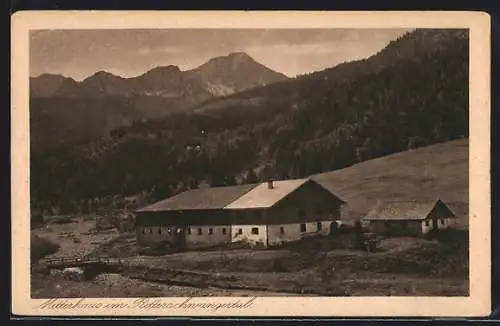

{"left": 30, "top": 52, "right": 288, "bottom": 98}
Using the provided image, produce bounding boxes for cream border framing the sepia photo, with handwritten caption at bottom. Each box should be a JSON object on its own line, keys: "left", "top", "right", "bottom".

{"left": 11, "top": 11, "right": 491, "bottom": 317}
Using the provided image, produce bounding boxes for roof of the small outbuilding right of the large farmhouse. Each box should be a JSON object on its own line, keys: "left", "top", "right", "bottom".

{"left": 363, "top": 199, "right": 455, "bottom": 221}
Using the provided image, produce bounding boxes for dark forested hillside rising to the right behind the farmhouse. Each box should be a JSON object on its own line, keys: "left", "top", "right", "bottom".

{"left": 31, "top": 30, "right": 468, "bottom": 214}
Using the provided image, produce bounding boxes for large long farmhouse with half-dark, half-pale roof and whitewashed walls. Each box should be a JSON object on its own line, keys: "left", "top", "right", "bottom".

{"left": 136, "top": 179, "right": 344, "bottom": 250}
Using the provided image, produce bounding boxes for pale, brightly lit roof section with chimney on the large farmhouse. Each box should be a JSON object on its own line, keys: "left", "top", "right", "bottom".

{"left": 225, "top": 179, "right": 309, "bottom": 209}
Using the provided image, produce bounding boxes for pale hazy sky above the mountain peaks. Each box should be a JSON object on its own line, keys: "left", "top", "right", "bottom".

{"left": 30, "top": 29, "right": 409, "bottom": 80}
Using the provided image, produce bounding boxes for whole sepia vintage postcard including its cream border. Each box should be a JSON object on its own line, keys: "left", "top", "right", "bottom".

{"left": 11, "top": 11, "right": 491, "bottom": 317}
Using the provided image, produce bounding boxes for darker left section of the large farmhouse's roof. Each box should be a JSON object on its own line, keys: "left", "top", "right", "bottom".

{"left": 137, "top": 184, "right": 258, "bottom": 213}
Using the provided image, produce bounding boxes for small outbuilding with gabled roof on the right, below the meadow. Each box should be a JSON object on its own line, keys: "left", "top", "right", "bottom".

{"left": 362, "top": 199, "right": 456, "bottom": 236}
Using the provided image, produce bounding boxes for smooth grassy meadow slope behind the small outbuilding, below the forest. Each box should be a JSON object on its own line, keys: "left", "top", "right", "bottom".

{"left": 313, "top": 139, "right": 469, "bottom": 227}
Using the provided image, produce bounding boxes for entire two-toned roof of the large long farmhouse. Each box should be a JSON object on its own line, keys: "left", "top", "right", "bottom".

{"left": 138, "top": 178, "right": 343, "bottom": 212}
